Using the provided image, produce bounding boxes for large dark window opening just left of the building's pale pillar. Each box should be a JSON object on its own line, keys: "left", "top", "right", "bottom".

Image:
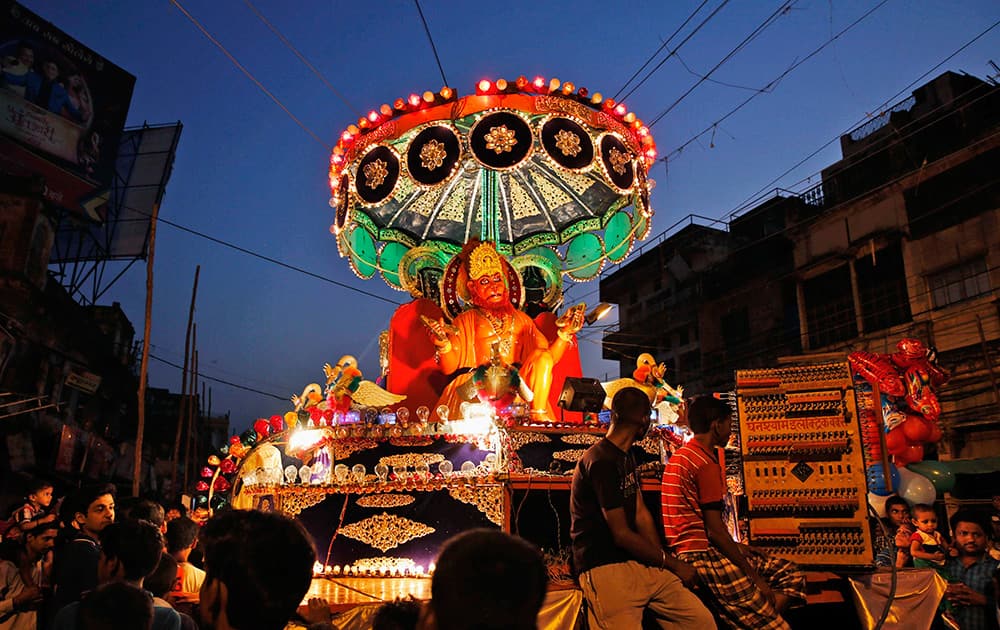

{"left": 802, "top": 265, "right": 858, "bottom": 348}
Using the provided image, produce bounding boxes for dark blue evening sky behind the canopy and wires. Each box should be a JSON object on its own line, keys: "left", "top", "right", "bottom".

{"left": 24, "top": 0, "right": 1000, "bottom": 428}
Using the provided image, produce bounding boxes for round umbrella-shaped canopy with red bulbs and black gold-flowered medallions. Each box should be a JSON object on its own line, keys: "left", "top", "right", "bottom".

{"left": 330, "top": 77, "right": 656, "bottom": 289}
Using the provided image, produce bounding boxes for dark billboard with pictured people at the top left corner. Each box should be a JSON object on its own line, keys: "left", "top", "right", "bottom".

{"left": 0, "top": 0, "right": 135, "bottom": 221}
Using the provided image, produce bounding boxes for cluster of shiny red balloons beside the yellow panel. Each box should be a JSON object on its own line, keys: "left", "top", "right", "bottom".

{"left": 848, "top": 338, "right": 950, "bottom": 466}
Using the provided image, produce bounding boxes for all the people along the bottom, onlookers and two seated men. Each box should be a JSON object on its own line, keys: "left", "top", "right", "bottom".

{"left": 0, "top": 388, "right": 1000, "bottom": 630}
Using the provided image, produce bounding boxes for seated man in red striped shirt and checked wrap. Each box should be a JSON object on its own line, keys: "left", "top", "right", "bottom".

{"left": 661, "top": 396, "right": 805, "bottom": 630}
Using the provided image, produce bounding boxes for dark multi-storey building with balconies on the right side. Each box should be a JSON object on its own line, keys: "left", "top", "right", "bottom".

{"left": 601, "top": 72, "right": 1000, "bottom": 458}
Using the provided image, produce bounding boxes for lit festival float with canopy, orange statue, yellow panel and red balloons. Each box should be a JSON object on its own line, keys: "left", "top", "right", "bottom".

{"left": 184, "top": 77, "right": 947, "bottom": 627}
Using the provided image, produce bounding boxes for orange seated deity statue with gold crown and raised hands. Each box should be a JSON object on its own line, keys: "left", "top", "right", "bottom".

{"left": 424, "top": 240, "right": 584, "bottom": 420}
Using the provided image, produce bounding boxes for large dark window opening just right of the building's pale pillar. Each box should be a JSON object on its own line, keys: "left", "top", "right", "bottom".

{"left": 854, "top": 242, "right": 912, "bottom": 332}
